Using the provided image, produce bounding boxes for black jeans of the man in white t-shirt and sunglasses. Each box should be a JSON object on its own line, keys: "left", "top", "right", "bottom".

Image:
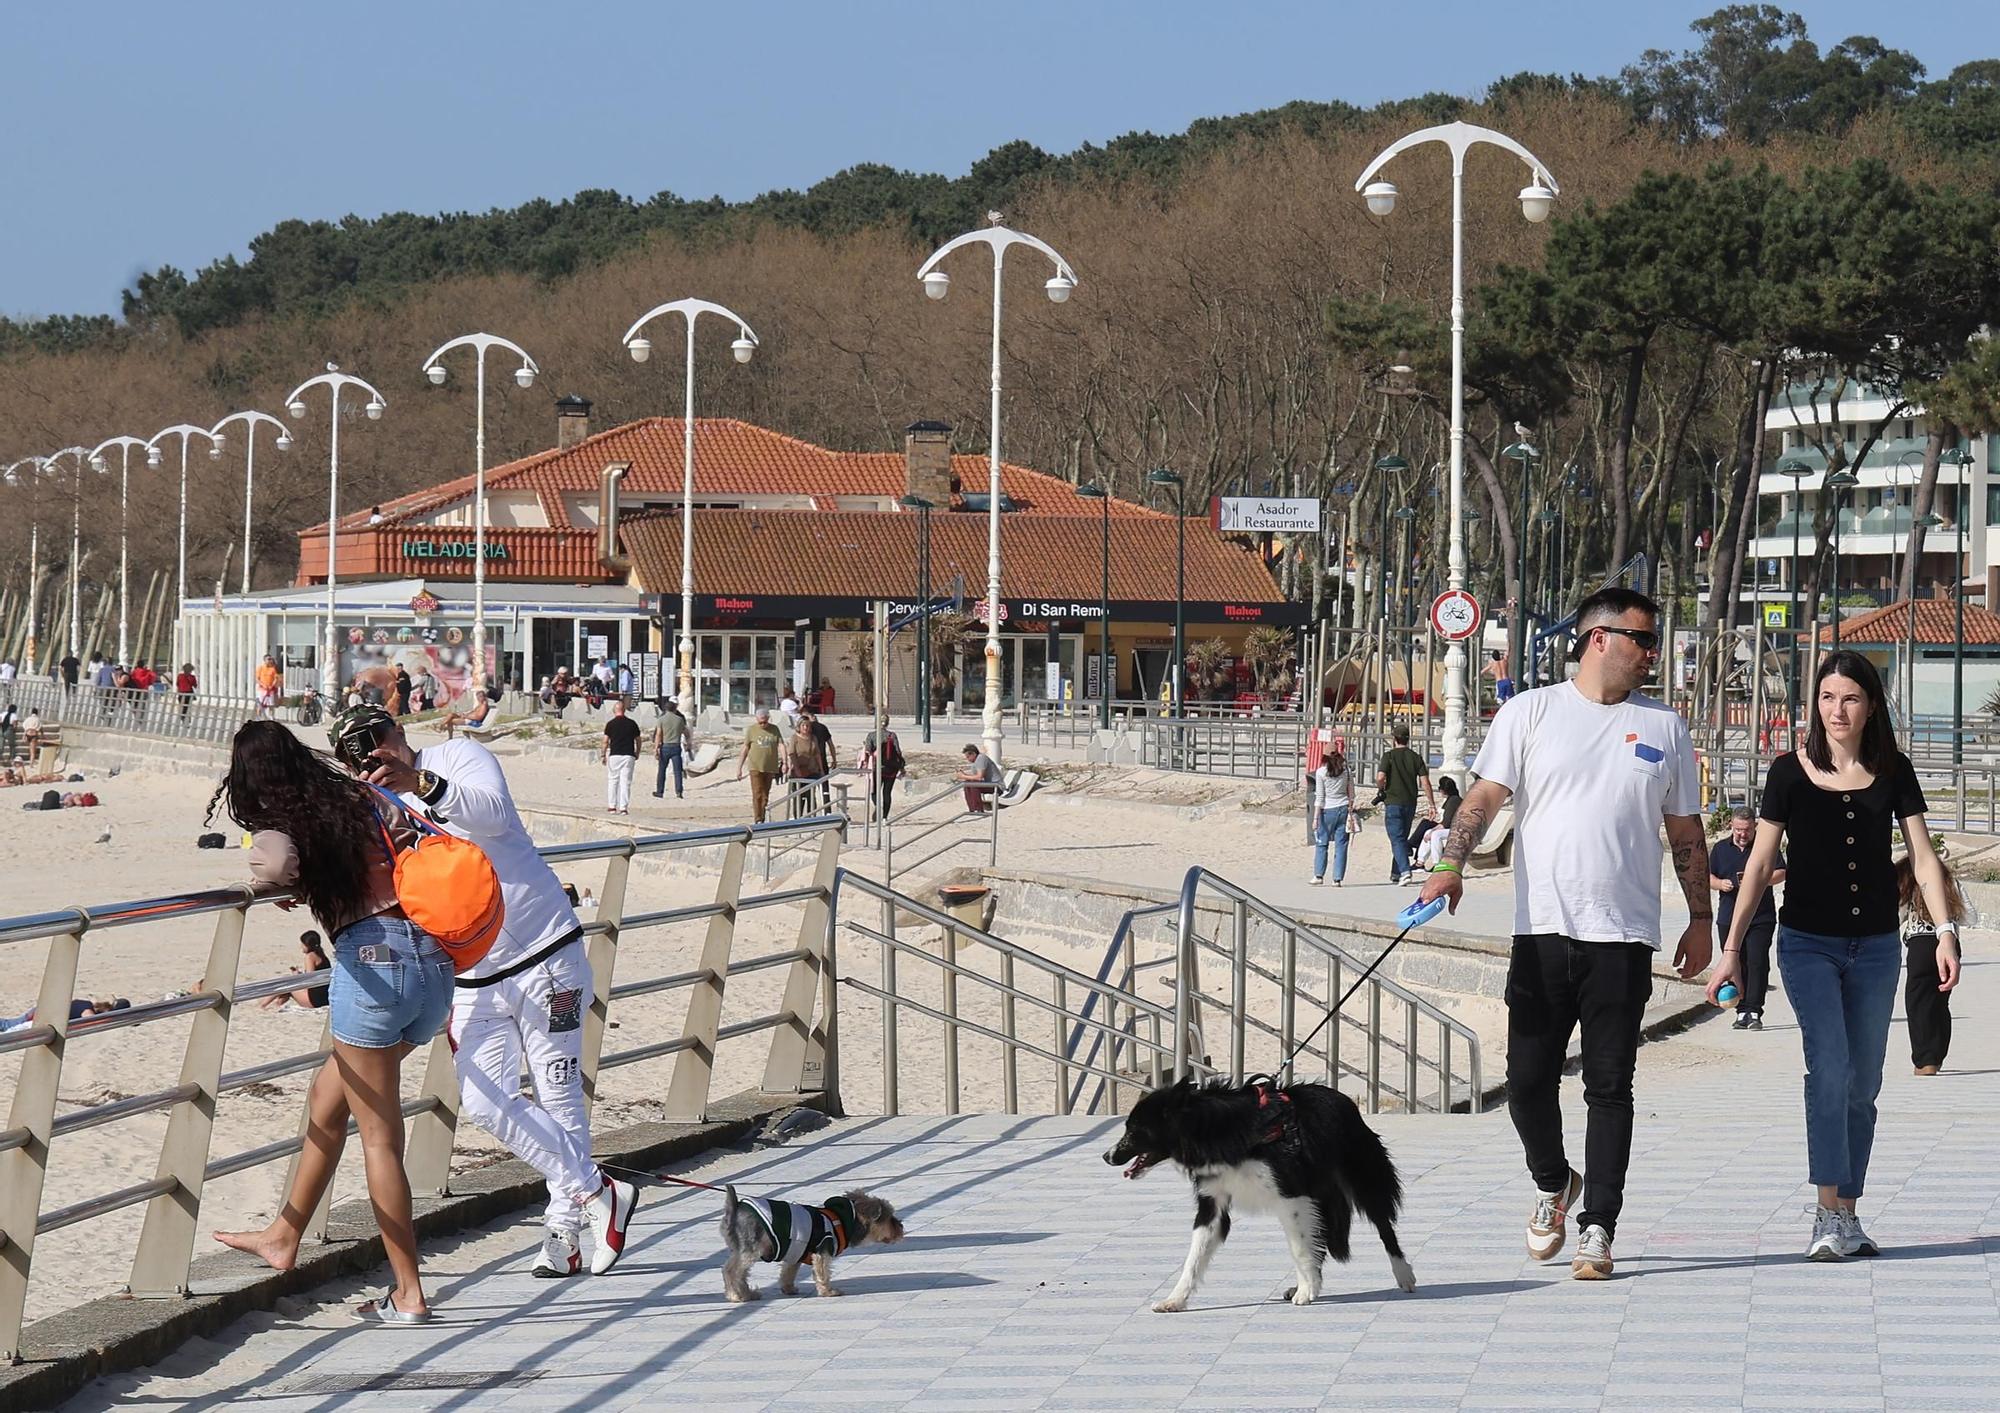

{"left": 1506, "top": 933, "right": 1654, "bottom": 1235}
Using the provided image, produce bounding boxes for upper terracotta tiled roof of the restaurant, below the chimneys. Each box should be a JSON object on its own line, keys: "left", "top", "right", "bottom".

{"left": 302, "top": 416, "right": 1168, "bottom": 532}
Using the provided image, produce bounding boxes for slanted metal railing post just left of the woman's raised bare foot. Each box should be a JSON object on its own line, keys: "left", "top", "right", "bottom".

{"left": 129, "top": 901, "right": 250, "bottom": 1299}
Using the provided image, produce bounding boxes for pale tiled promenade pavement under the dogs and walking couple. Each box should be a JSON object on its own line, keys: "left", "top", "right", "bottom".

{"left": 72, "top": 933, "right": 2000, "bottom": 1413}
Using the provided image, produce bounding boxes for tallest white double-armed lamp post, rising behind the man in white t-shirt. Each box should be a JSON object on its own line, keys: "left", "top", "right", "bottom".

{"left": 1354, "top": 122, "right": 1560, "bottom": 781}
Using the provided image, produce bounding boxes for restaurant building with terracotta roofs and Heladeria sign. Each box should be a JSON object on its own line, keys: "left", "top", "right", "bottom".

{"left": 182, "top": 398, "right": 1304, "bottom": 711}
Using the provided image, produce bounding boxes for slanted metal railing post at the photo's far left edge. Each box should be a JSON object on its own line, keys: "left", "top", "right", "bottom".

{"left": 0, "top": 929, "right": 84, "bottom": 1363}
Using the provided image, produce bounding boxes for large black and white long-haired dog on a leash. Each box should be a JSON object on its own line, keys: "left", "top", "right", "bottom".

{"left": 1104, "top": 1079, "right": 1416, "bottom": 1313}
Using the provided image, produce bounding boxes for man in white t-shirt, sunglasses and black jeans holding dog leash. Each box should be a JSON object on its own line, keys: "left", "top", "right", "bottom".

{"left": 1418, "top": 588, "right": 1714, "bottom": 1281}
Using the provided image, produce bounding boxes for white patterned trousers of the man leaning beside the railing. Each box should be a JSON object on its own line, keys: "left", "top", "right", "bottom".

{"left": 450, "top": 939, "right": 604, "bottom": 1233}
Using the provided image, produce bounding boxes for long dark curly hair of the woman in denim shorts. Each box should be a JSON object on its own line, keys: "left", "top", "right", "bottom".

{"left": 204, "top": 721, "right": 384, "bottom": 931}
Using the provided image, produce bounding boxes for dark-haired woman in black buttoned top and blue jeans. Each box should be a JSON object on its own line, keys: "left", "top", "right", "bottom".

{"left": 1708, "top": 652, "right": 1958, "bottom": 1261}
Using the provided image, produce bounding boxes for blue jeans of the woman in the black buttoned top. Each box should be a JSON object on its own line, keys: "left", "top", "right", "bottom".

{"left": 1778, "top": 925, "right": 1902, "bottom": 1197}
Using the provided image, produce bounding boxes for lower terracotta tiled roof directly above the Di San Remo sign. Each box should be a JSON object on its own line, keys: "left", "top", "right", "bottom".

{"left": 620, "top": 510, "right": 1284, "bottom": 602}
